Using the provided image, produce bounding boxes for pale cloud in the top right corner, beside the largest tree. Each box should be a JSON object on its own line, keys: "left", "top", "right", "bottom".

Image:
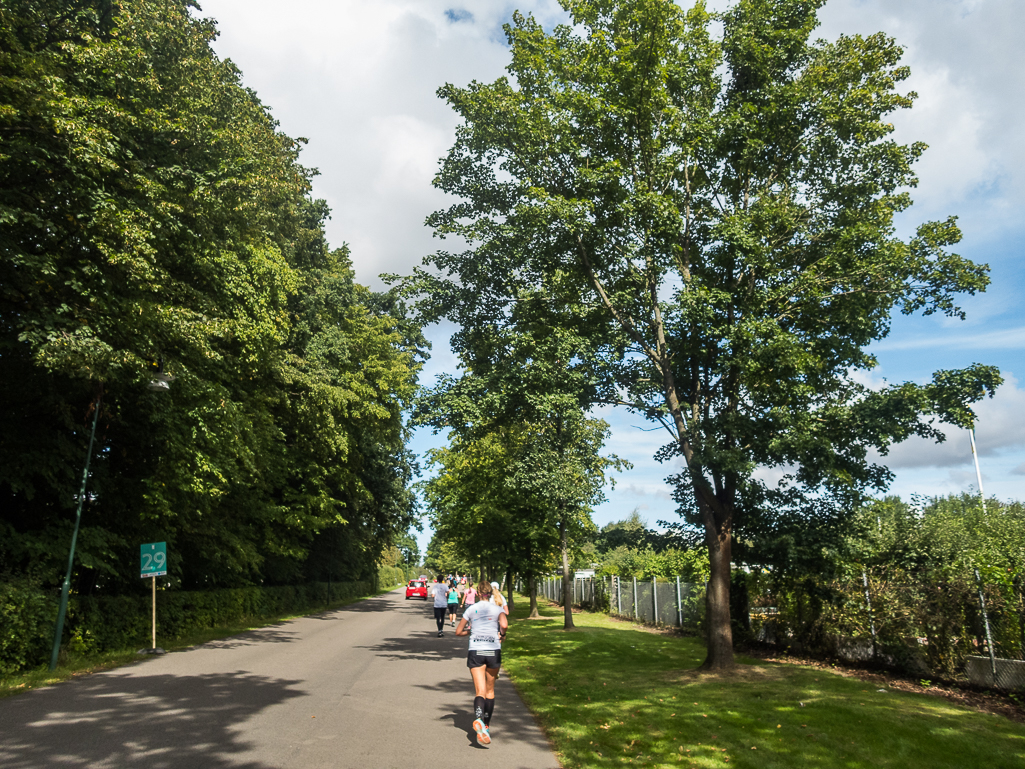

{"left": 820, "top": 0, "right": 1025, "bottom": 231}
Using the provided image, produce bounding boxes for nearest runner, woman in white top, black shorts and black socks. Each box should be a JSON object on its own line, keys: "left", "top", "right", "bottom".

{"left": 455, "top": 582, "right": 509, "bottom": 745}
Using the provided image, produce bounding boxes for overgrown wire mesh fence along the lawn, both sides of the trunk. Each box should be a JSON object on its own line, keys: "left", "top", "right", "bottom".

{"left": 521, "top": 567, "right": 1025, "bottom": 690}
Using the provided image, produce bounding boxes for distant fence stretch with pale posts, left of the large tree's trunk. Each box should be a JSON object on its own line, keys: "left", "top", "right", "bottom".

{"left": 538, "top": 575, "right": 704, "bottom": 633}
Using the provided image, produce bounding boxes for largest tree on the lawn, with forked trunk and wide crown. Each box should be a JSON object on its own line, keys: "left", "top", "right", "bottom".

{"left": 409, "top": 0, "right": 999, "bottom": 669}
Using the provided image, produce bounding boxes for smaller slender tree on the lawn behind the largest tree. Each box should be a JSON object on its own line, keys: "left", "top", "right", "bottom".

{"left": 418, "top": 297, "right": 627, "bottom": 628}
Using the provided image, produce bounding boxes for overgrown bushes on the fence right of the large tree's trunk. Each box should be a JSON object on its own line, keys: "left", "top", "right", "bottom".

{"left": 748, "top": 566, "right": 1025, "bottom": 690}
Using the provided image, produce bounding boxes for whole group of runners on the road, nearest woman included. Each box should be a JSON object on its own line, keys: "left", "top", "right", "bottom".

{"left": 428, "top": 574, "right": 509, "bottom": 745}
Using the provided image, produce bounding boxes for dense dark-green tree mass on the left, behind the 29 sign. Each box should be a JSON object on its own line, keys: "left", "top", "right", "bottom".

{"left": 0, "top": 0, "right": 424, "bottom": 592}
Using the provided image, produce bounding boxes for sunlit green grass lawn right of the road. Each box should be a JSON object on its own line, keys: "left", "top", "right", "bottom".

{"left": 504, "top": 599, "right": 1025, "bottom": 769}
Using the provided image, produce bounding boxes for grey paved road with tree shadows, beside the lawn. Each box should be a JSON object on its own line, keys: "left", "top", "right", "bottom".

{"left": 0, "top": 591, "right": 559, "bottom": 769}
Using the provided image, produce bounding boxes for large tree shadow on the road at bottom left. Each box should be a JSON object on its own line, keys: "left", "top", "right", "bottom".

{"left": 0, "top": 672, "right": 303, "bottom": 769}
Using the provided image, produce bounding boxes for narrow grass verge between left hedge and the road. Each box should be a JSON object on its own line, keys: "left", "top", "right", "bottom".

{"left": 0, "top": 585, "right": 399, "bottom": 698}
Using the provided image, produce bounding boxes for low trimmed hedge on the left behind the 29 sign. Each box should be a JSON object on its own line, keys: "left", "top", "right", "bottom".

{"left": 0, "top": 580, "right": 377, "bottom": 675}
